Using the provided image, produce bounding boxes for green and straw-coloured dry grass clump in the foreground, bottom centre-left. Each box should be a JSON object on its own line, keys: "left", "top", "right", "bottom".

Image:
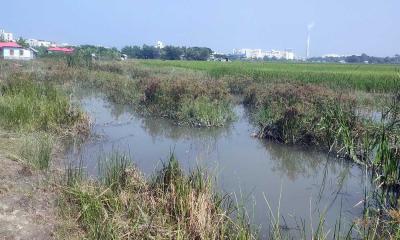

{"left": 62, "top": 153, "right": 255, "bottom": 239}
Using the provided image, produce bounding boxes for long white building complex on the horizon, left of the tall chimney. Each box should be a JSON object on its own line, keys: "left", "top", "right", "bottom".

{"left": 233, "top": 48, "right": 294, "bottom": 60}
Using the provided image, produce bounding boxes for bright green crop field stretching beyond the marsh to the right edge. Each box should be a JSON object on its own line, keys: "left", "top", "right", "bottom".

{"left": 140, "top": 60, "right": 399, "bottom": 92}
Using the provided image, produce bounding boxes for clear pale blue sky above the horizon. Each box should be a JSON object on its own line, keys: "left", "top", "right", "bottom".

{"left": 0, "top": 0, "right": 400, "bottom": 56}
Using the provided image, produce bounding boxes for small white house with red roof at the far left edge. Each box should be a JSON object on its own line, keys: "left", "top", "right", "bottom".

{"left": 0, "top": 42, "right": 35, "bottom": 60}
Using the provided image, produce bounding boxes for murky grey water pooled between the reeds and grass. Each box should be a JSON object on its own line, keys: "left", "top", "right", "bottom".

{"left": 69, "top": 95, "right": 365, "bottom": 238}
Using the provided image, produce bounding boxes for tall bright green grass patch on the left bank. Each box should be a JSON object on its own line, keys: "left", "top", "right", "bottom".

{"left": 0, "top": 73, "right": 83, "bottom": 132}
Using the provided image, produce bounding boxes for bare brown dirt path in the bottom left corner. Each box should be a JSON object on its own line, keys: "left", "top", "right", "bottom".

{"left": 0, "top": 156, "right": 56, "bottom": 240}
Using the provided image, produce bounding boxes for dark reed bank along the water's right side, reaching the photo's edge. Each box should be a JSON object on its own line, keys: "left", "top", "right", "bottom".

{"left": 245, "top": 81, "right": 400, "bottom": 186}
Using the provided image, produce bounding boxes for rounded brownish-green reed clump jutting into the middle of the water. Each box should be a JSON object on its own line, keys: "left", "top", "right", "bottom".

{"left": 138, "top": 74, "right": 234, "bottom": 127}
